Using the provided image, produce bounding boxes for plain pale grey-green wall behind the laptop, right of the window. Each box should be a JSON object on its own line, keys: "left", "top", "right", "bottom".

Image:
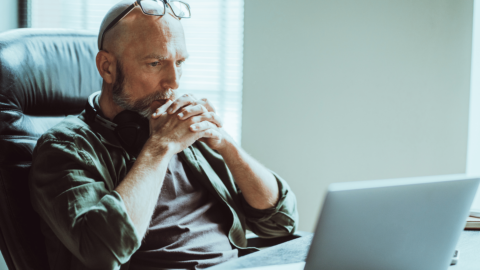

{"left": 242, "top": 0, "right": 473, "bottom": 231}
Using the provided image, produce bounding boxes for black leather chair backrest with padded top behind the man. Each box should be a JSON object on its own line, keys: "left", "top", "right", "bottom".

{"left": 0, "top": 29, "right": 101, "bottom": 270}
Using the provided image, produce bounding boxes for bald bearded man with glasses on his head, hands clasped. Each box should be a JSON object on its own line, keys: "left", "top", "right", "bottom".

{"left": 30, "top": 0, "right": 298, "bottom": 270}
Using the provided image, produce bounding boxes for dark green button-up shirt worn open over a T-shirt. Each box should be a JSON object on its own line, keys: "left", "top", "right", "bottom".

{"left": 29, "top": 114, "right": 298, "bottom": 270}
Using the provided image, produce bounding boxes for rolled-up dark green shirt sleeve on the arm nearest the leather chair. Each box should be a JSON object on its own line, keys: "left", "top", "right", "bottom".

{"left": 29, "top": 140, "right": 141, "bottom": 269}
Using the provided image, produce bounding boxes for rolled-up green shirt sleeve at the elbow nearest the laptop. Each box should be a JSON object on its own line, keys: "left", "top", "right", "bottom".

{"left": 241, "top": 172, "right": 298, "bottom": 238}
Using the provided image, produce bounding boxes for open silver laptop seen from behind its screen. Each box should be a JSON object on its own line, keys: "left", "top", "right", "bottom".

{"left": 244, "top": 175, "right": 480, "bottom": 270}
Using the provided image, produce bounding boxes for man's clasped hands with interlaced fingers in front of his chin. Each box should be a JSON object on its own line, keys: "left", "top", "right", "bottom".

{"left": 149, "top": 94, "right": 231, "bottom": 153}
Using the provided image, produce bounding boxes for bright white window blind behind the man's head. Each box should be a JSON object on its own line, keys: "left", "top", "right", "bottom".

{"left": 31, "top": 0, "right": 244, "bottom": 143}
